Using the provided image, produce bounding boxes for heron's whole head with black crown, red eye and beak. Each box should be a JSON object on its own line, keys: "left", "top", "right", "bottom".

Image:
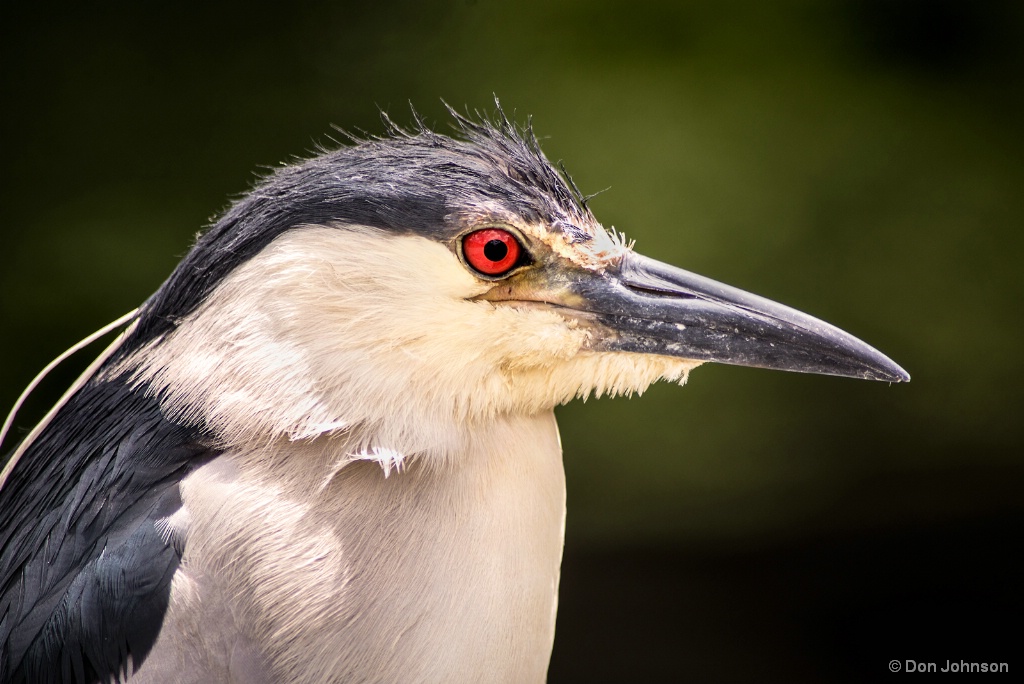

{"left": 119, "top": 108, "right": 908, "bottom": 458}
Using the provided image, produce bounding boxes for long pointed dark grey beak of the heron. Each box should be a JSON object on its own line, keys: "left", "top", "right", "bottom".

{"left": 572, "top": 253, "right": 910, "bottom": 382}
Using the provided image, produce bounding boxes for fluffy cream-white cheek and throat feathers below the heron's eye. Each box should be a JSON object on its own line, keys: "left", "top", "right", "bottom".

{"left": 113, "top": 226, "right": 696, "bottom": 458}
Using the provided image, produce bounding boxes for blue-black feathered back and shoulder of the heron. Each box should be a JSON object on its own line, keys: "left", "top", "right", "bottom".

{"left": 0, "top": 378, "right": 213, "bottom": 682}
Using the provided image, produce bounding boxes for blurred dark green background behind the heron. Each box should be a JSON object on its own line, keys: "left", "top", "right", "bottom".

{"left": 0, "top": 0, "right": 1024, "bottom": 682}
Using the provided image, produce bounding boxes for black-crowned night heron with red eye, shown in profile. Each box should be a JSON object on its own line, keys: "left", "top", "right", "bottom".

{"left": 0, "top": 107, "right": 908, "bottom": 684}
